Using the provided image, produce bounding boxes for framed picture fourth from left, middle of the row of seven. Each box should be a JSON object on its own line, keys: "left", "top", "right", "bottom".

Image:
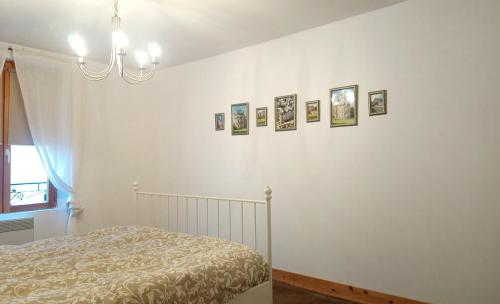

{"left": 274, "top": 94, "right": 297, "bottom": 131}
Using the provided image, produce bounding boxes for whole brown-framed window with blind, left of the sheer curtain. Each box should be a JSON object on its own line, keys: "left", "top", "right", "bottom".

{"left": 0, "top": 61, "right": 56, "bottom": 213}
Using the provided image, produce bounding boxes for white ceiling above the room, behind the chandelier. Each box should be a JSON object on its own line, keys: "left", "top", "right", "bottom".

{"left": 0, "top": 0, "right": 402, "bottom": 67}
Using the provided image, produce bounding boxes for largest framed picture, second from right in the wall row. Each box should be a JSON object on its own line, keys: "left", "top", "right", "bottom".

{"left": 330, "top": 85, "right": 358, "bottom": 128}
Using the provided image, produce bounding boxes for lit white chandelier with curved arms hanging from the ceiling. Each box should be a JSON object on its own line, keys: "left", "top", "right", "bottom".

{"left": 68, "top": 0, "right": 161, "bottom": 84}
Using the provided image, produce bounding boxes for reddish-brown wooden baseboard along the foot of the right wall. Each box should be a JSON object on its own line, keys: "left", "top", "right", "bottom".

{"left": 273, "top": 269, "right": 426, "bottom": 304}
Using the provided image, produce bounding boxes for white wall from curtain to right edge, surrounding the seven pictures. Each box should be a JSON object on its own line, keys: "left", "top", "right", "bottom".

{"left": 76, "top": 0, "right": 500, "bottom": 304}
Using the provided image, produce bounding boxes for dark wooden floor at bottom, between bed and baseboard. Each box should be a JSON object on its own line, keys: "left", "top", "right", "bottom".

{"left": 273, "top": 281, "right": 355, "bottom": 304}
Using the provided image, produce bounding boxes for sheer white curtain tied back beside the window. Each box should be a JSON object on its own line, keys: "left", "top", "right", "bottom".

{"left": 13, "top": 49, "right": 82, "bottom": 233}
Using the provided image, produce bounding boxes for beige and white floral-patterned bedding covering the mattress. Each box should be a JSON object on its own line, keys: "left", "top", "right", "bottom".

{"left": 0, "top": 226, "right": 269, "bottom": 304}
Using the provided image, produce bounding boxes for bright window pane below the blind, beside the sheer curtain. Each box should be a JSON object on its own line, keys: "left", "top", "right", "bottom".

{"left": 10, "top": 146, "right": 49, "bottom": 206}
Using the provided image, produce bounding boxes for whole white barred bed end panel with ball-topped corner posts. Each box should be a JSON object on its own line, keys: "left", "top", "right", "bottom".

{"left": 132, "top": 182, "right": 272, "bottom": 282}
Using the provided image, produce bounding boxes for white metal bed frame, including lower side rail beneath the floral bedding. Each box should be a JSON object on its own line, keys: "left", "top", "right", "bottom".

{"left": 132, "top": 182, "right": 273, "bottom": 304}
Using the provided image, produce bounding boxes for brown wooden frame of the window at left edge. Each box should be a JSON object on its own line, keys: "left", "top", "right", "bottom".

{"left": 0, "top": 60, "right": 57, "bottom": 214}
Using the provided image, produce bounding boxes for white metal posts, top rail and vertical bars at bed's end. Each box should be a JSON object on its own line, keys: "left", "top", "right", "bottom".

{"left": 132, "top": 182, "right": 272, "bottom": 282}
